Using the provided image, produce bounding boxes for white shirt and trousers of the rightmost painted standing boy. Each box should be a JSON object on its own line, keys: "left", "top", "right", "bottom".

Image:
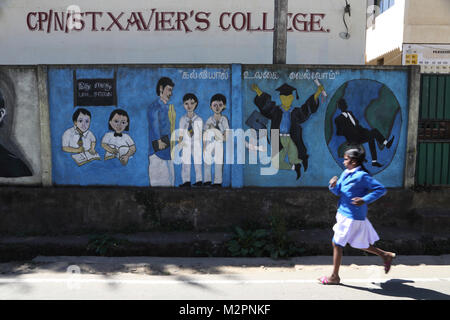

{"left": 203, "top": 115, "right": 230, "bottom": 184}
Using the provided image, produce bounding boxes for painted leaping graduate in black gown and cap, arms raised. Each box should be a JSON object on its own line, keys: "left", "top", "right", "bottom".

{"left": 251, "top": 83, "right": 323, "bottom": 180}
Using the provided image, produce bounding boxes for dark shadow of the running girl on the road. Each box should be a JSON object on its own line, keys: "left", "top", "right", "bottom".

{"left": 341, "top": 279, "right": 450, "bottom": 300}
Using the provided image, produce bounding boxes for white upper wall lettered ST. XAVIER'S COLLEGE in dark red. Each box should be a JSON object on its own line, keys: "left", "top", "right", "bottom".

{"left": 0, "top": 0, "right": 366, "bottom": 64}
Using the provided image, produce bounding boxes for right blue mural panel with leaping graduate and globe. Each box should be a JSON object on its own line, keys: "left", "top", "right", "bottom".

{"left": 243, "top": 66, "right": 408, "bottom": 187}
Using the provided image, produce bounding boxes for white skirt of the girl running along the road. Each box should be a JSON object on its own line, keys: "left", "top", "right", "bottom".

{"left": 333, "top": 212, "right": 380, "bottom": 249}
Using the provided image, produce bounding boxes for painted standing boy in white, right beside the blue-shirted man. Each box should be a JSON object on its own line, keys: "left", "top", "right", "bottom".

{"left": 178, "top": 93, "right": 203, "bottom": 187}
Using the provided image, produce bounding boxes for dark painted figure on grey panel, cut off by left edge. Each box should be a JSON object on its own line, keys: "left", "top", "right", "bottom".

{"left": 0, "top": 72, "right": 33, "bottom": 178}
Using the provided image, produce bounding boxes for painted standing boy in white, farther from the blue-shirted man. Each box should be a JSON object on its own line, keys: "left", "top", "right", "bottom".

{"left": 203, "top": 93, "right": 230, "bottom": 187}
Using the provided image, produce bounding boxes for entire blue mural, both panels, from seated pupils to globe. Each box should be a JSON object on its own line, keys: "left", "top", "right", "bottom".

{"left": 49, "top": 65, "right": 408, "bottom": 187}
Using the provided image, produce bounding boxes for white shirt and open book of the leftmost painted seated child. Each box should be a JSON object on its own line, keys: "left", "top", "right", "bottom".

{"left": 62, "top": 126, "right": 100, "bottom": 166}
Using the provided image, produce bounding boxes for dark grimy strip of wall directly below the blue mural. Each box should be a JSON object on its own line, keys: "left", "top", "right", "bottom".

{"left": 0, "top": 187, "right": 450, "bottom": 236}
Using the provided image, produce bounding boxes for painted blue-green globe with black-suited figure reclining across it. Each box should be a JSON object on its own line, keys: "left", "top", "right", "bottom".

{"left": 325, "top": 79, "right": 402, "bottom": 175}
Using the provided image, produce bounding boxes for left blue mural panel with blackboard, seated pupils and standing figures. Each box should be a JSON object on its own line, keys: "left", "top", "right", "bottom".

{"left": 49, "top": 66, "right": 231, "bottom": 187}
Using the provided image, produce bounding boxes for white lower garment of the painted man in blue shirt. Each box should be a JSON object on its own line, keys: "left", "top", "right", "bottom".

{"left": 148, "top": 154, "right": 175, "bottom": 187}
